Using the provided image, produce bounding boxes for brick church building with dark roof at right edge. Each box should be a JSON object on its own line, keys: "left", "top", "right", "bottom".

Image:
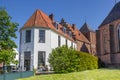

{"left": 96, "top": 2, "right": 120, "bottom": 67}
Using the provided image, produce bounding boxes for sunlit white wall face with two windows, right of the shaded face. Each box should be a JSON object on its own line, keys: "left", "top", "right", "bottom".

{"left": 34, "top": 28, "right": 51, "bottom": 68}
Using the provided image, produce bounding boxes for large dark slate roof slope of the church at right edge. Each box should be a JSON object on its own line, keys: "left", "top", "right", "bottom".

{"left": 100, "top": 2, "right": 120, "bottom": 26}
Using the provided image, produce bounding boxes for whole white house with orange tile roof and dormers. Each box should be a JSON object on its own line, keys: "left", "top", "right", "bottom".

{"left": 19, "top": 10, "right": 95, "bottom": 70}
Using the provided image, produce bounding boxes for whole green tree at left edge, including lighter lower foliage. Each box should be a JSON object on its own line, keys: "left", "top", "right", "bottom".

{"left": 0, "top": 8, "right": 18, "bottom": 64}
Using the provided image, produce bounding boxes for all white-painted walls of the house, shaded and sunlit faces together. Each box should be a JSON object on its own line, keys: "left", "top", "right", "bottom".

{"left": 20, "top": 28, "right": 76, "bottom": 70}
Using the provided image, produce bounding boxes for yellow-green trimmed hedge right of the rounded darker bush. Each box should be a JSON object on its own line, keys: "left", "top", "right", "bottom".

{"left": 77, "top": 51, "right": 98, "bottom": 71}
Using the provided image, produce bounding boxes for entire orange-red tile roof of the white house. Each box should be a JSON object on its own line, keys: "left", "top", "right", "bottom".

{"left": 21, "top": 10, "right": 89, "bottom": 43}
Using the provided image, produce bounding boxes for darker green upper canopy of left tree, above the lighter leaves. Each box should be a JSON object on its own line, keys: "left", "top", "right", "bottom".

{"left": 0, "top": 8, "right": 18, "bottom": 49}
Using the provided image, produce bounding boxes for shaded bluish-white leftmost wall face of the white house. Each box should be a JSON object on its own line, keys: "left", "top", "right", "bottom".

{"left": 20, "top": 28, "right": 34, "bottom": 70}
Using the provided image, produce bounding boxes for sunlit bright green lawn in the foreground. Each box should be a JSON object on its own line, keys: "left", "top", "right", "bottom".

{"left": 19, "top": 69, "right": 120, "bottom": 80}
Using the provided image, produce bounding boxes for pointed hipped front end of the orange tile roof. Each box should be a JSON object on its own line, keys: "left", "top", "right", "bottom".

{"left": 22, "top": 10, "right": 53, "bottom": 29}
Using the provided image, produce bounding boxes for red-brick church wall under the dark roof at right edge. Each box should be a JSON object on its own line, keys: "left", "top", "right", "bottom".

{"left": 97, "top": 20, "right": 120, "bottom": 64}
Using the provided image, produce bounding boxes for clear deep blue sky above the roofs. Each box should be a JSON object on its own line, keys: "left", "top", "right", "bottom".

{"left": 0, "top": 0, "right": 118, "bottom": 50}
